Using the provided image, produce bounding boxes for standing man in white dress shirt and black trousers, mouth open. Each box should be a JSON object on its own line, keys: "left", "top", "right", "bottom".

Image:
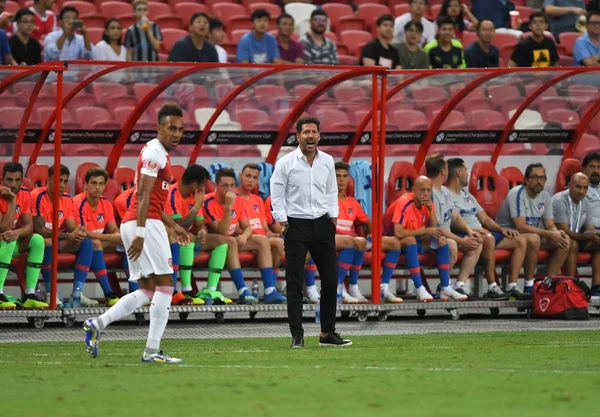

{"left": 271, "top": 116, "right": 352, "bottom": 348}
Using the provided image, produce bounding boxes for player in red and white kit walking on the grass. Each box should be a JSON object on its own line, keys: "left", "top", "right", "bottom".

{"left": 83, "top": 104, "right": 188, "bottom": 363}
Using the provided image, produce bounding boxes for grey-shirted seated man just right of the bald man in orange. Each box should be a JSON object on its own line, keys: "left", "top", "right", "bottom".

{"left": 425, "top": 153, "right": 483, "bottom": 295}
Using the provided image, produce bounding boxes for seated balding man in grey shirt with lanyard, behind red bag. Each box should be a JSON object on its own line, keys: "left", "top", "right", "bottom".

{"left": 552, "top": 172, "right": 600, "bottom": 290}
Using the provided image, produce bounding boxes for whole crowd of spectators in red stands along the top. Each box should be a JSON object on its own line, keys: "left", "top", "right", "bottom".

{"left": 0, "top": 0, "right": 600, "bottom": 69}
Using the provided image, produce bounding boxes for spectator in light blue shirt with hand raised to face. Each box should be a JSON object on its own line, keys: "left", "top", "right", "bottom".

{"left": 44, "top": 6, "right": 93, "bottom": 62}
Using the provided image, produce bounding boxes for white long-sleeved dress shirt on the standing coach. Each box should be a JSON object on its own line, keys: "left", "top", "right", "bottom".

{"left": 271, "top": 148, "right": 339, "bottom": 223}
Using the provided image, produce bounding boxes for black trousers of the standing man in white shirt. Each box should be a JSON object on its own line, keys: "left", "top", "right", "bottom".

{"left": 285, "top": 215, "right": 337, "bottom": 337}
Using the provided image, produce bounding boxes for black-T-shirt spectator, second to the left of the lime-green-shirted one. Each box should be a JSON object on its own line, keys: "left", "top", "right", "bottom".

{"left": 360, "top": 14, "right": 401, "bottom": 69}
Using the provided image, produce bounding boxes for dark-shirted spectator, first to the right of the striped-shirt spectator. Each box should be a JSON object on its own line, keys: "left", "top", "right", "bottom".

{"left": 167, "top": 13, "right": 219, "bottom": 62}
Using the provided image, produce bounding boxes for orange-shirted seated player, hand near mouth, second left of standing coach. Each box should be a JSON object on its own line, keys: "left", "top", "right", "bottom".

{"left": 204, "top": 168, "right": 287, "bottom": 304}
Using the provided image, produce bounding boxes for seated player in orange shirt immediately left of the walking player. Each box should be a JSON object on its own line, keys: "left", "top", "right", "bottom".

{"left": 73, "top": 168, "right": 123, "bottom": 307}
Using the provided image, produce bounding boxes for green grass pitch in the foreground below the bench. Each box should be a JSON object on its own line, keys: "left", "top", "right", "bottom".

{"left": 0, "top": 331, "right": 600, "bottom": 417}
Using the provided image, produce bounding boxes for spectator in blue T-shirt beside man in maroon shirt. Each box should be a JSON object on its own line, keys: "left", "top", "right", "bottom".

{"left": 237, "top": 9, "right": 282, "bottom": 64}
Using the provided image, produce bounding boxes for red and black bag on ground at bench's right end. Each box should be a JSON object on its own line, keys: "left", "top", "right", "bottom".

{"left": 532, "top": 277, "right": 590, "bottom": 320}
